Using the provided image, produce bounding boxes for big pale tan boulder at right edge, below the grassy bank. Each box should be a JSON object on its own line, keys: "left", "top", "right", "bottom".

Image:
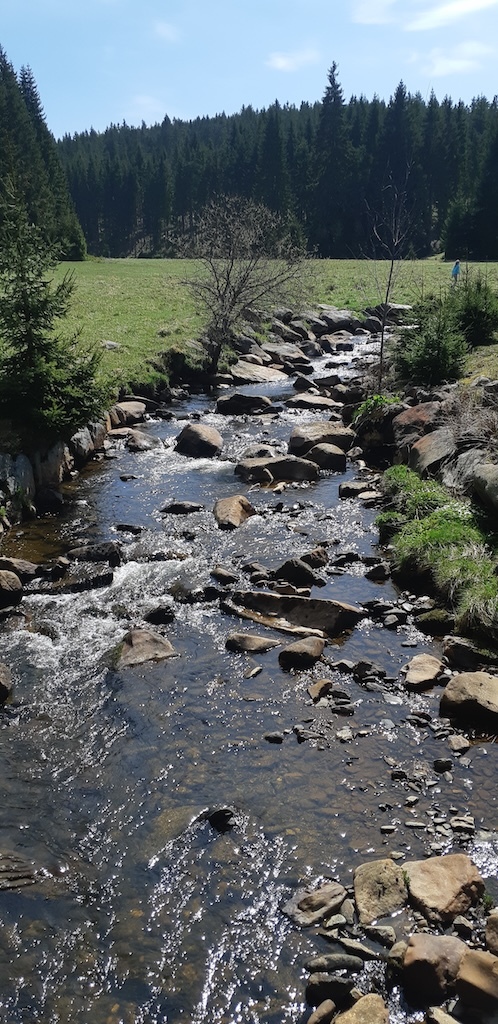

{"left": 441, "top": 672, "right": 498, "bottom": 729}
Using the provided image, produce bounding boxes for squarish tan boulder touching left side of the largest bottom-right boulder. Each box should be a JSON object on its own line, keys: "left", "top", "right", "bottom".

{"left": 355, "top": 857, "right": 408, "bottom": 925}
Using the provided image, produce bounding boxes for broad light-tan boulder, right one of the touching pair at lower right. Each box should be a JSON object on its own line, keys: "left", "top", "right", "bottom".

{"left": 404, "top": 853, "right": 485, "bottom": 925}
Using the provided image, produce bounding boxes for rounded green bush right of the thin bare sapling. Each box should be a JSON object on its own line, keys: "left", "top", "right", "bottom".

{"left": 393, "top": 302, "right": 467, "bottom": 386}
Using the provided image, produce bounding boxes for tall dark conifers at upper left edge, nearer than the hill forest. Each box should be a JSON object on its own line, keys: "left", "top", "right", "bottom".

{"left": 0, "top": 47, "right": 86, "bottom": 260}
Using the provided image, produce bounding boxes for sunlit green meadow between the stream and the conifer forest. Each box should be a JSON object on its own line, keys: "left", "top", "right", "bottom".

{"left": 57, "top": 256, "right": 498, "bottom": 391}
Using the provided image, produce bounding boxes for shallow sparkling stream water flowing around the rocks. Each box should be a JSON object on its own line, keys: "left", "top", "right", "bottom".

{"left": 0, "top": 354, "right": 497, "bottom": 1024}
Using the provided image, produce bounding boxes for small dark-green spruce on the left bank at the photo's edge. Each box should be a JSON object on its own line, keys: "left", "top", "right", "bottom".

{"left": 0, "top": 185, "right": 102, "bottom": 437}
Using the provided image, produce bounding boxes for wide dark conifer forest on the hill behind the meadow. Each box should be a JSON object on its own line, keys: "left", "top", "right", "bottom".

{"left": 59, "top": 65, "right": 498, "bottom": 259}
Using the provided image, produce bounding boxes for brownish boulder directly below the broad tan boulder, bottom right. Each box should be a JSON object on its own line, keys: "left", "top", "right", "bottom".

{"left": 403, "top": 932, "right": 467, "bottom": 1006}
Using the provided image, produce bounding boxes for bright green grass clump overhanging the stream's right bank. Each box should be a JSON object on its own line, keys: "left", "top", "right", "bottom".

{"left": 377, "top": 466, "right": 498, "bottom": 643}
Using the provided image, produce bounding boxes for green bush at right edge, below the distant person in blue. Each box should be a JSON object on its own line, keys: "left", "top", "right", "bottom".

{"left": 445, "top": 271, "right": 498, "bottom": 348}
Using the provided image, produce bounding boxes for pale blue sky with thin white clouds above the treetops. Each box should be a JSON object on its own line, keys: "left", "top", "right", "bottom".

{"left": 0, "top": 0, "right": 498, "bottom": 137}
